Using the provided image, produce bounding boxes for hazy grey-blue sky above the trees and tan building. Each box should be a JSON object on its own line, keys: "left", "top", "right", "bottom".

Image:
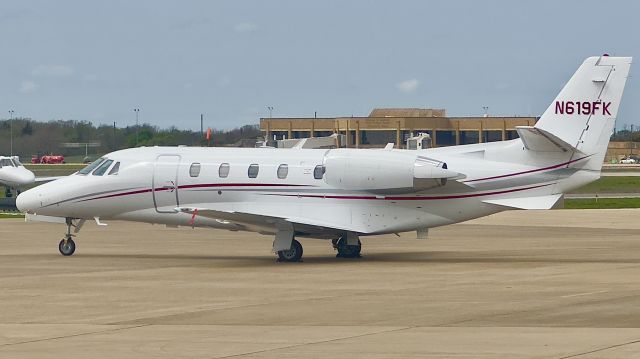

{"left": 0, "top": 0, "right": 640, "bottom": 129}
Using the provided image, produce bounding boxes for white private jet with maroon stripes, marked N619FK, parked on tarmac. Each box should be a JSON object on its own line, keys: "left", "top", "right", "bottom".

{"left": 17, "top": 56, "right": 631, "bottom": 262}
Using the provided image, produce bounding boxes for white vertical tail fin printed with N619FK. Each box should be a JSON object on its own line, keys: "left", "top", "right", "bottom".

{"left": 535, "top": 56, "right": 631, "bottom": 170}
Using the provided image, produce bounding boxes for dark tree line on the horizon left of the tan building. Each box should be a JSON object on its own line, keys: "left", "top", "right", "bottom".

{"left": 0, "top": 118, "right": 260, "bottom": 162}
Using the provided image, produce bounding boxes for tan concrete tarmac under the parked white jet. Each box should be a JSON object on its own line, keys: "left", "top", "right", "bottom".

{"left": 0, "top": 210, "right": 640, "bottom": 359}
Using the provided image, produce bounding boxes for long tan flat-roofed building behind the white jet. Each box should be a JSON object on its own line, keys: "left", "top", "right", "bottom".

{"left": 260, "top": 108, "right": 537, "bottom": 148}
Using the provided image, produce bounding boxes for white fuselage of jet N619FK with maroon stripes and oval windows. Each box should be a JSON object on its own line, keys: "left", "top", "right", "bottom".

{"left": 17, "top": 139, "right": 599, "bottom": 237}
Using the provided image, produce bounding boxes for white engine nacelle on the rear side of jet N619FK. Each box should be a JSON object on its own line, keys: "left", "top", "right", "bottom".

{"left": 324, "top": 150, "right": 459, "bottom": 193}
